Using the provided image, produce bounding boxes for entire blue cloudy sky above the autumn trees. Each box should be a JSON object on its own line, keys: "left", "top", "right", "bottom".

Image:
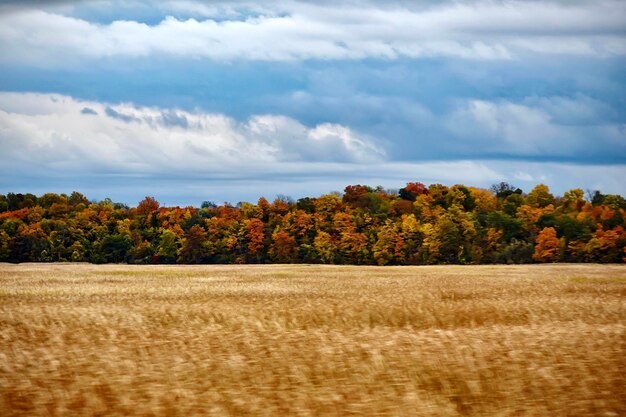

{"left": 0, "top": 0, "right": 626, "bottom": 206}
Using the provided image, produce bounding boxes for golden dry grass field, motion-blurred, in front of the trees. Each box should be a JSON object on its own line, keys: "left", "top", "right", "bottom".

{"left": 0, "top": 264, "right": 626, "bottom": 417}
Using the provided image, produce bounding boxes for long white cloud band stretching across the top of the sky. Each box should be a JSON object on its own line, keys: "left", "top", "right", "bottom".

{"left": 0, "top": 0, "right": 626, "bottom": 65}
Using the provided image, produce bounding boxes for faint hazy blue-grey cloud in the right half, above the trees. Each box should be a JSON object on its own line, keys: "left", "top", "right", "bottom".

{"left": 445, "top": 97, "right": 626, "bottom": 160}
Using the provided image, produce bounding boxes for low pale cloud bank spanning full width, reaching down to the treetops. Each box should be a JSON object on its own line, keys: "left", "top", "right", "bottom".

{"left": 0, "top": 92, "right": 626, "bottom": 204}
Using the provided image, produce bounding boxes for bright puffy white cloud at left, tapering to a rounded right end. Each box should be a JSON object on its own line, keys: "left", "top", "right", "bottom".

{"left": 0, "top": 93, "right": 385, "bottom": 173}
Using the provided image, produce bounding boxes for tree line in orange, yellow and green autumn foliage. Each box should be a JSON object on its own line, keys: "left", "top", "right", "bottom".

{"left": 0, "top": 182, "right": 626, "bottom": 265}
